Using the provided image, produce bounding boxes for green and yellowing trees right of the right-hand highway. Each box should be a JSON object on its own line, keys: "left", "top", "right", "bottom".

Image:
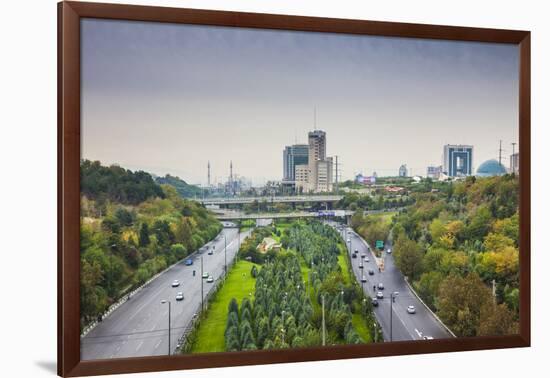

{"left": 392, "top": 175, "right": 519, "bottom": 336}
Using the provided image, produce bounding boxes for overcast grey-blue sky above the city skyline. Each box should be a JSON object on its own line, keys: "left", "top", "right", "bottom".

{"left": 82, "top": 19, "right": 519, "bottom": 184}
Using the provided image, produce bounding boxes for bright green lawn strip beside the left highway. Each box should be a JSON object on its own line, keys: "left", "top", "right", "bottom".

{"left": 191, "top": 260, "right": 256, "bottom": 353}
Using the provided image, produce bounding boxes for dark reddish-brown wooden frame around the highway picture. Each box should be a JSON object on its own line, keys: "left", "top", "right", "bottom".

{"left": 57, "top": 2, "right": 531, "bottom": 376}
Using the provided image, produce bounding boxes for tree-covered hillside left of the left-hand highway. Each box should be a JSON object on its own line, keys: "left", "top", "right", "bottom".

{"left": 80, "top": 161, "right": 221, "bottom": 324}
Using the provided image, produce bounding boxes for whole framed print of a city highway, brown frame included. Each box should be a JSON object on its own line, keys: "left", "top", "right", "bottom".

{"left": 58, "top": 2, "right": 530, "bottom": 376}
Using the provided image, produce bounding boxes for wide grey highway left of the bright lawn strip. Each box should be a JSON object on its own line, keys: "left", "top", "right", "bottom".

{"left": 80, "top": 224, "right": 252, "bottom": 360}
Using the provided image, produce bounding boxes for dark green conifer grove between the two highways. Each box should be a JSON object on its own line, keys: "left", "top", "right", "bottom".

{"left": 225, "top": 221, "right": 373, "bottom": 351}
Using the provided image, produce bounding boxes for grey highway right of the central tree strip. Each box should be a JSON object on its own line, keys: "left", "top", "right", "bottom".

{"left": 341, "top": 227, "right": 452, "bottom": 341}
